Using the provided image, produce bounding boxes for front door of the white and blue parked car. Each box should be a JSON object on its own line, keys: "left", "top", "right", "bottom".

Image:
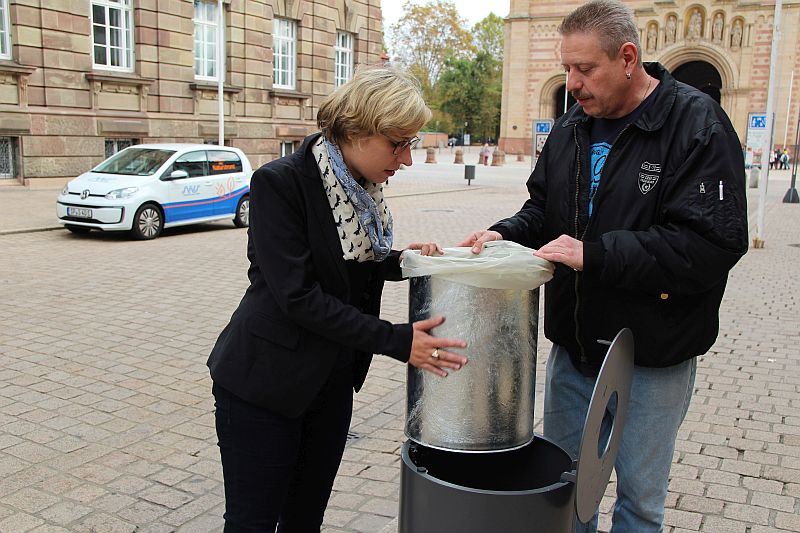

{"left": 162, "top": 150, "right": 216, "bottom": 224}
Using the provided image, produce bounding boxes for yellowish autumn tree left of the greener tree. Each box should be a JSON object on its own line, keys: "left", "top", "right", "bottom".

{"left": 390, "top": 0, "right": 474, "bottom": 94}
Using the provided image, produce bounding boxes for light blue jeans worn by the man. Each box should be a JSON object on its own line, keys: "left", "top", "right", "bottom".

{"left": 544, "top": 345, "right": 697, "bottom": 533}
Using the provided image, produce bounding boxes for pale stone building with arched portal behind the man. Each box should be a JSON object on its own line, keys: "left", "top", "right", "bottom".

{"left": 500, "top": 0, "right": 800, "bottom": 159}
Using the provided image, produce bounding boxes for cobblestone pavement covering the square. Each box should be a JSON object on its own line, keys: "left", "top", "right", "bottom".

{"left": 0, "top": 164, "right": 800, "bottom": 533}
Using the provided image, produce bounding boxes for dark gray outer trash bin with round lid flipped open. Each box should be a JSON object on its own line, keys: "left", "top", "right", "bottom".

{"left": 398, "top": 329, "right": 634, "bottom": 533}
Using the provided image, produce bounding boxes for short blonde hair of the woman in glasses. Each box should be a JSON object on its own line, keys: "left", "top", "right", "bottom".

{"left": 317, "top": 66, "right": 431, "bottom": 143}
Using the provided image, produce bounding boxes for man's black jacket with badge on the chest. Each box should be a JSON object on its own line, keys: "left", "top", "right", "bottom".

{"left": 491, "top": 63, "right": 748, "bottom": 374}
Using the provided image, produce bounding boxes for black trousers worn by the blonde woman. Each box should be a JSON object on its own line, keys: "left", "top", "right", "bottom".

{"left": 213, "top": 365, "right": 353, "bottom": 533}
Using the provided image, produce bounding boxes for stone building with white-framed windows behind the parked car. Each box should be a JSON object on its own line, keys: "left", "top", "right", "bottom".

{"left": 0, "top": 0, "right": 383, "bottom": 186}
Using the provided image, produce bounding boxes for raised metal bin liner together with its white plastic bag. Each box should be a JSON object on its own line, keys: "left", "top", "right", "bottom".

{"left": 403, "top": 241, "right": 553, "bottom": 452}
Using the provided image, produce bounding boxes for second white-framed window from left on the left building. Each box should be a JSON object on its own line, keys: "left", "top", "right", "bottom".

{"left": 92, "top": 0, "right": 133, "bottom": 71}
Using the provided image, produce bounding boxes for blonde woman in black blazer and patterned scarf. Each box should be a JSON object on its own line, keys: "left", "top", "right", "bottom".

{"left": 208, "top": 64, "right": 467, "bottom": 533}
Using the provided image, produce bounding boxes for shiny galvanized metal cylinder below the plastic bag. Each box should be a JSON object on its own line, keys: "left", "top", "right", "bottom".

{"left": 405, "top": 275, "right": 539, "bottom": 452}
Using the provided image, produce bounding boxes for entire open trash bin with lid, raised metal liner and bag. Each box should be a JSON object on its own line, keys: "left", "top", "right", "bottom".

{"left": 398, "top": 246, "right": 633, "bottom": 533}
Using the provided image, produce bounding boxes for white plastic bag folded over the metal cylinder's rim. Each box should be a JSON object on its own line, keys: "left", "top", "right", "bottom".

{"left": 400, "top": 241, "right": 555, "bottom": 290}
